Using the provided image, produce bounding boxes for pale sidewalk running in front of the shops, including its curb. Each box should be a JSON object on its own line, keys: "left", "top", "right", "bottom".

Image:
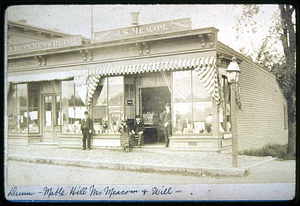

{"left": 7, "top": 145, "right": 275, "bottom": 176}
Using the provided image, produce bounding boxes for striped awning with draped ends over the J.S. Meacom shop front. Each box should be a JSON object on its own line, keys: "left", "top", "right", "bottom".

{"left": 87, "top": 56, "right": 220, "bottom": 105}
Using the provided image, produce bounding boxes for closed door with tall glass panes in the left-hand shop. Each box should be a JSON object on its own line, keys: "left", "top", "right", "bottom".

{"left": 42, "top": 94, "right": 61, "bottom": 143}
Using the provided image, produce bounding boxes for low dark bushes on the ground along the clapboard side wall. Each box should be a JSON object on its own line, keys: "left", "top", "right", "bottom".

{"left": 240, "top": 144, "right": 295, "bottom": 160}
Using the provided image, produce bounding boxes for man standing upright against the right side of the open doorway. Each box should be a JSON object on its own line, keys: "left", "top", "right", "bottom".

{"left": 159, "top": 103, "right": 172, "bottom": 147}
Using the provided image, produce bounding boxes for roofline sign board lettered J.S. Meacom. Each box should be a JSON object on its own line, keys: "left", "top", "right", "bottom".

{"left": 94, "top": 18, "right": 192, "bottom": 42}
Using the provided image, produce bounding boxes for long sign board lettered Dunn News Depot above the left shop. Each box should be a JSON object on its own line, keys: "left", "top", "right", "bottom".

{"left": 7, "top": 36, "right": 82, "bottom": 54}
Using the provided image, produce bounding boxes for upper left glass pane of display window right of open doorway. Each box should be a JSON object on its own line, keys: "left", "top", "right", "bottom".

{"left": 173, "top": 71, "right": 191, "bottom": 102}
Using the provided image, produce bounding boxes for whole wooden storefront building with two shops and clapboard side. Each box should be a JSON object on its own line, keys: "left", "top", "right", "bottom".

{"left": 6, "top": 19, "right": 287, "bottom": 152}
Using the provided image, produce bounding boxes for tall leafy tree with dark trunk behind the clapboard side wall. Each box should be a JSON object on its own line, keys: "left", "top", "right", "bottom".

{"left": 235, "top": 4, "right": 296, "bottom": 156}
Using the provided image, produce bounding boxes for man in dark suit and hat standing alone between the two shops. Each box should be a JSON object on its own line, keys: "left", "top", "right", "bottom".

{"left": 81, "top": 111, "right": 94, "bottom": 150}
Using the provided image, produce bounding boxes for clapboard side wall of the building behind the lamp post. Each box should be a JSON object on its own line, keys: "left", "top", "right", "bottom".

{"left": 218, "top": 43, "right": 288, "bottom": 151}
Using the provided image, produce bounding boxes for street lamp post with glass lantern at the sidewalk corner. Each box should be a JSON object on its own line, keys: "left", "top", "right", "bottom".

{"left": 226, "top": 56, "right": 240, "bottom": 167}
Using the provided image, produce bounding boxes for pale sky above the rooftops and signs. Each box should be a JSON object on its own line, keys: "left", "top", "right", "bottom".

{"left": 7, "top": 4, "right": 278, "bottom": 53}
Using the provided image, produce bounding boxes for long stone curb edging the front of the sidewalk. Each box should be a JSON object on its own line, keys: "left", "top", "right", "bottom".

{"left": 8, "top": 155, "right": 247, "bottom": 177}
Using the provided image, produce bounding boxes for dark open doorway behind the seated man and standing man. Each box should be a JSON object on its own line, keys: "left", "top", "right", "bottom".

{"left": 140, "top": 87, "right": 171, "bottom": 145}
